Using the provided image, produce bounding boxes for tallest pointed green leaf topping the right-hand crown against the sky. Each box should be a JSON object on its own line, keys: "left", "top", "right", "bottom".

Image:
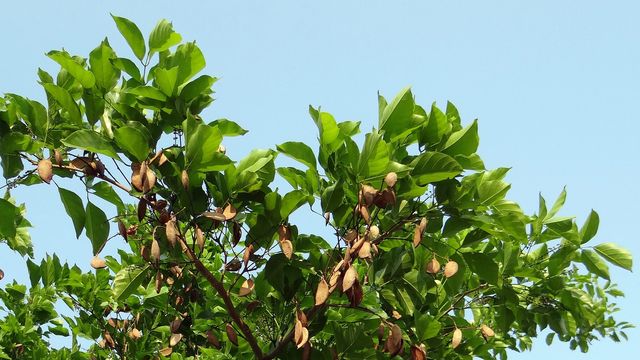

{"left": 378, "top": 87, "right": 420, "bottom": 142}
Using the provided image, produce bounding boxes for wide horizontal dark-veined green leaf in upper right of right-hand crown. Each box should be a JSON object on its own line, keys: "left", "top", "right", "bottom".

{"left": 411, "top": 151, "right": 462, "bottom": 186}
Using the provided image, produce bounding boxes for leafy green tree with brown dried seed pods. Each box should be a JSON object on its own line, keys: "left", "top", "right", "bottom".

{"left": 0, "top": 16, "right": 632, "bottom": 359}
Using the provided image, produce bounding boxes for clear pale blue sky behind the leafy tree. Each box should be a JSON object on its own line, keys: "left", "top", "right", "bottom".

{"left": 0, "top": 0, "right": 640, "bottom": 360}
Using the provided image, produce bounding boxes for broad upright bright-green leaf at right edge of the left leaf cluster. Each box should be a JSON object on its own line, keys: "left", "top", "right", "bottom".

{"left": 185, "top": 123, "right": 230, "bottom": 172}
